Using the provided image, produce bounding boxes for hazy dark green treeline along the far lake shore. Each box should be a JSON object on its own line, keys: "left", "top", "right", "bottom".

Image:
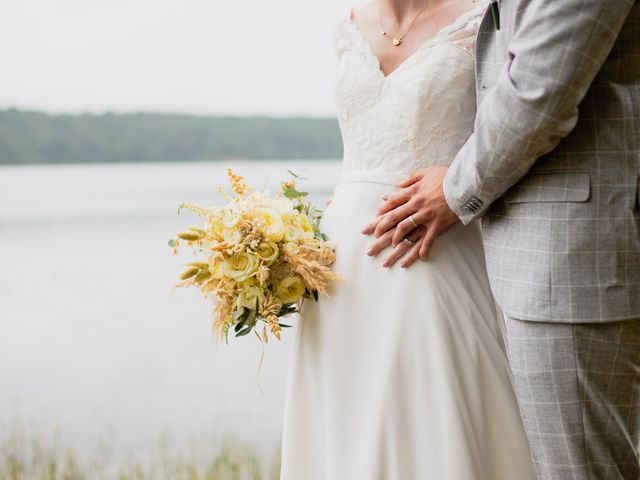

{"left": 0, "top": 109, "right": 342, "bottom": 164}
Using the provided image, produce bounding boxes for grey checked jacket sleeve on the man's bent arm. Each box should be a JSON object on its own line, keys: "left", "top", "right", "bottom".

{"left": 444, "top": 0, "right": 634, "bottom": 224}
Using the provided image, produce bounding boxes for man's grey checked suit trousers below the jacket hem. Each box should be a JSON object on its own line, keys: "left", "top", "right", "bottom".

{"left": 506, "top": 318, "right": 640, "bottom": 480}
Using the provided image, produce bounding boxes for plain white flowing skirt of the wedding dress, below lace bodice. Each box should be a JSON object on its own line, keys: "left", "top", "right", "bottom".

{"left": 281, "top": 171, "right": 535, "bottom": 480}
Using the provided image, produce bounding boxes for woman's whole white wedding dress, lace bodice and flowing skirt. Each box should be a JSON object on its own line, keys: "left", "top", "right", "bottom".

{"left": 281, "top": 6, "right": 535, "bottom": 480}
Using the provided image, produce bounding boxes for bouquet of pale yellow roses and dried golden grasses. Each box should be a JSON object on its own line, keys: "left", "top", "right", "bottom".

{"left": 169, "top": 169, "right": 340, "bottom": 343}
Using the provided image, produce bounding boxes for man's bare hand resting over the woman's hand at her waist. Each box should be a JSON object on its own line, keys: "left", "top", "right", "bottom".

{"left": 362, "top": 167, "right": 459, "bottom": 260}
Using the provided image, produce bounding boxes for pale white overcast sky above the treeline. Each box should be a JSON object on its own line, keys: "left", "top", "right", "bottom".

{"left": 0, "top": 0, "right": 360, "bottom": 115}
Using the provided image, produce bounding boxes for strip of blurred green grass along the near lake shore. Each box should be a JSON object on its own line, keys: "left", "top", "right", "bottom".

{"left": 0, "top": 434, "right": 280, "bottom": 480}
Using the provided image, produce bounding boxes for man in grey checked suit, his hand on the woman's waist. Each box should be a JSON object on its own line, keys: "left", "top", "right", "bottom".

{"left": 365, "top": 0, "right": 640, "bottom": 480}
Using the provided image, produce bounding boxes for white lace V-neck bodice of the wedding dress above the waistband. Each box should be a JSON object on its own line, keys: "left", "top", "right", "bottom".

{"left": 334, "top": 4, "right": 485, "bottom": 173}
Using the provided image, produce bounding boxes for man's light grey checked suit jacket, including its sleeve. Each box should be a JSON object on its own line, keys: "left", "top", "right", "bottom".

{"left": 444, "top": 0, "right": 640, "bottom": 323}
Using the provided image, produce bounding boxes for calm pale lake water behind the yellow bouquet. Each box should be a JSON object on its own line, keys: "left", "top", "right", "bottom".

{"left": 0, "top": 160, "right": 340, "bottom": 466}
